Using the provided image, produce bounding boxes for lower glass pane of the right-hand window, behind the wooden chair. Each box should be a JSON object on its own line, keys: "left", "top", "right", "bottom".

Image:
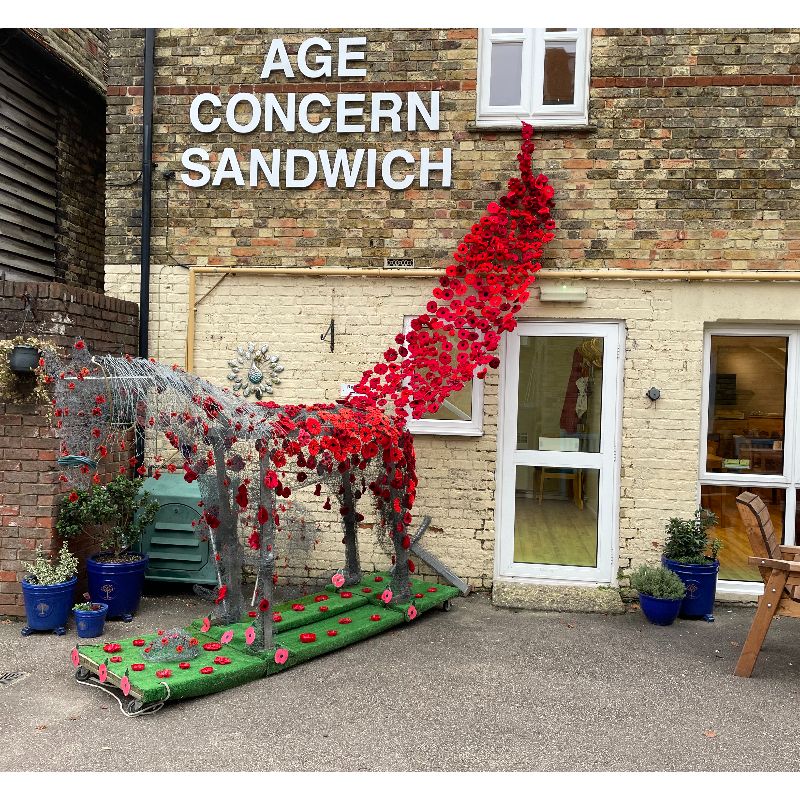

{"left": 700, "top": 485, "right": 786, "bottom": 581}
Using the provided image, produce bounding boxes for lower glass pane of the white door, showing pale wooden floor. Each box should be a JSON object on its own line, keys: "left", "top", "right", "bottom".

{"left": 514, "top": 467, "right": 600, "bottom": 567}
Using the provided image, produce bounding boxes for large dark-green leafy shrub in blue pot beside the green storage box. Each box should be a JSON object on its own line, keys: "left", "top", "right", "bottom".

{"left": 56, "top": 475, "right": 158, "bottom": 622}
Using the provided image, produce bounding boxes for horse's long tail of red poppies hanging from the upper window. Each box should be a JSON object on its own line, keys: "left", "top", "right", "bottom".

{"left": 349, "top": 123, "right": 555, "bottom": 419}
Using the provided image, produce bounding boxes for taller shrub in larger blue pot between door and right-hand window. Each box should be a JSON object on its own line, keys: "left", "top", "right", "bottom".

{"left": 662, "top": 508, "right": 722, "bottom": 622}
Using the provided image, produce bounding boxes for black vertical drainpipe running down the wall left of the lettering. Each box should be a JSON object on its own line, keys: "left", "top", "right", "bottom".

{"left": 135, "top": 28, "right": 156, "bottom": 468}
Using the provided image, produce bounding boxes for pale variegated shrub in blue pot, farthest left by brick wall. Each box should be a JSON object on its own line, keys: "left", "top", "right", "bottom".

{"left": 20, "top": 542, "right": 78, "bottom": 636}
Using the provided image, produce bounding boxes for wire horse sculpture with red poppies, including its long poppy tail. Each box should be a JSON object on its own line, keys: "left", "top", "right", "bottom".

{"left": 45, "top": 124, "right": 555, "bottom": 650}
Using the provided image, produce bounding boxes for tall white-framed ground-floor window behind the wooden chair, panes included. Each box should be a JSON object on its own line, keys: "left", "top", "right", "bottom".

{"left": 698, "top": 325, "right": 800, "bottom": 594}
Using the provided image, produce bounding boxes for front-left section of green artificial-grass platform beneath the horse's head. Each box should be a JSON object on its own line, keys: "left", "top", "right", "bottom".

{"left": 78, "top": 634, "right": 266, "bottom": 703}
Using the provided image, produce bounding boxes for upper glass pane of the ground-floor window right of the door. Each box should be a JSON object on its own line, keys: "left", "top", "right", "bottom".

{"left": 706, "top": 336, "right": 788, "bottom": 475}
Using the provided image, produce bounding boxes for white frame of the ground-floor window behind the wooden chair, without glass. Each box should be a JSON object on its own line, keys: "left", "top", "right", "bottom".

{"left": 697, "top": 325, "right": 800, "bottom": 595}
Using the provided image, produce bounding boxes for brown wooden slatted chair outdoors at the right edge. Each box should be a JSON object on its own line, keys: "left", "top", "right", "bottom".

{"left": 734, "top": 492, "right": 800, "bottom": 678}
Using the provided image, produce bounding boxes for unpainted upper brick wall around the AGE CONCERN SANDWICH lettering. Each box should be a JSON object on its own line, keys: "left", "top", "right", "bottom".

{"left": 107, "top": 29, "right": 800, "bottom": 269}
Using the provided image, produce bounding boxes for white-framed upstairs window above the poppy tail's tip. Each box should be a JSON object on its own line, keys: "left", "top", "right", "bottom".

{"left": 476, "top": 28, "right": 591, "bottom": 128}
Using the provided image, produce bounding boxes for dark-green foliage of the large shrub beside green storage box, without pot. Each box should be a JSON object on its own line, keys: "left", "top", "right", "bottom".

{"left": 56, "top": 475, "right": 159, "bottom": 561}
